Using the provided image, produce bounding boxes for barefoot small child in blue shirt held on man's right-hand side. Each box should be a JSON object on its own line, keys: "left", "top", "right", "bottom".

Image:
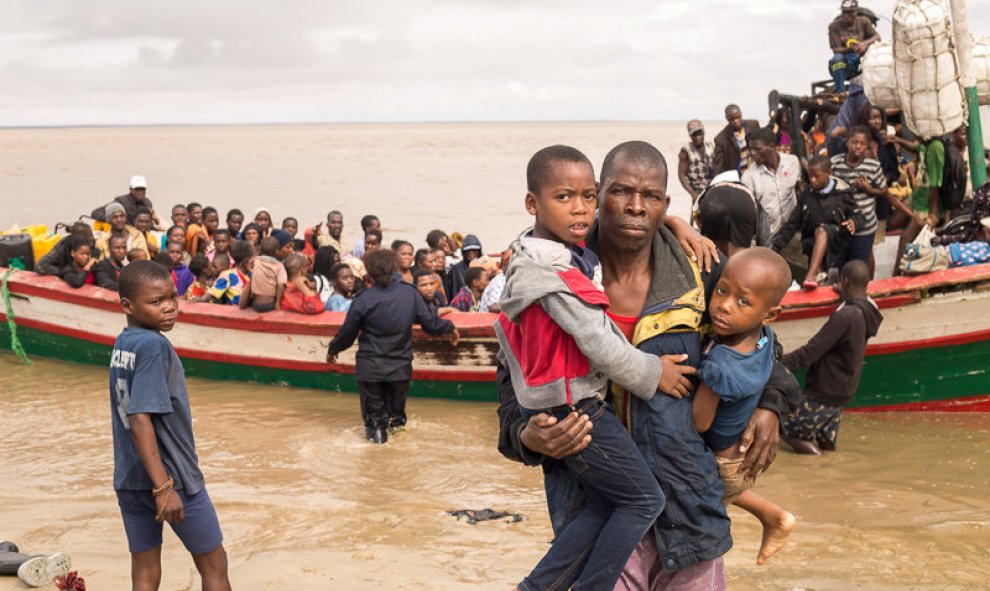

{"left": 693, "top": 247, "right": 795, "bottom": 565}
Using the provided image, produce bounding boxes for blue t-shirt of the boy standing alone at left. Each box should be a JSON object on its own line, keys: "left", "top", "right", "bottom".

{"left": 110, "top": 327, "right": 204, "bottom": 495}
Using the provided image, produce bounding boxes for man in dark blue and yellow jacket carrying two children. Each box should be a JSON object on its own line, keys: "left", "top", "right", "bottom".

{"left": 496, "top": 142, "right": 798, "bottom": 591}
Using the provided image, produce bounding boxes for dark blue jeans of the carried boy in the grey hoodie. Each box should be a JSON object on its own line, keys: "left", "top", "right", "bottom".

{"left": 519, "top": 398, "right": 665, "bottom": 591}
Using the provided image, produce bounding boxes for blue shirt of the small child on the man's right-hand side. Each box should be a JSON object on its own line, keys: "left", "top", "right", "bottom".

{"left": 698, "top": 326, "right": 774, "bottom": 451}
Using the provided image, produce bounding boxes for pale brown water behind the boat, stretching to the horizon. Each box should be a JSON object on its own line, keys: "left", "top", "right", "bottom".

{"left": 0, "top": 122, "right": 696, "bottom": 251}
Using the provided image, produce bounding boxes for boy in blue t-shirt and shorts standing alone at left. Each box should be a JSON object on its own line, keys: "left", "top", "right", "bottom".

{"left": 110, "top": 261, "right": 230, "bottom": 591}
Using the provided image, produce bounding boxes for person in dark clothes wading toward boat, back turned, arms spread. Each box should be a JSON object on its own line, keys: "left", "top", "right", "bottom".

{"left": 327, "top": 249, "right": 460, "bottom": 443}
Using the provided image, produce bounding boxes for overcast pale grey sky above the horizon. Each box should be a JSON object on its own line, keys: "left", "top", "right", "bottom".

{"left": 0, "top": 0, "right": 990, "bottom": 126}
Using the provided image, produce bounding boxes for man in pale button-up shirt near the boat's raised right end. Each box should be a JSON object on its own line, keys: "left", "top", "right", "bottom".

{"left": 742, "top": 127, "right": 808, "bottom": 278}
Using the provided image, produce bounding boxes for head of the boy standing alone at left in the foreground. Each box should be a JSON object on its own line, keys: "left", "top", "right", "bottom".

{"left": 117, "top": 261, "right": 179, "bottom": 332}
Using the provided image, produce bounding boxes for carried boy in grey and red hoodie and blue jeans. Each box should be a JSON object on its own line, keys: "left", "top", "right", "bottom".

{"left": 495, "top": 146, "right": 693, "bottom": 591}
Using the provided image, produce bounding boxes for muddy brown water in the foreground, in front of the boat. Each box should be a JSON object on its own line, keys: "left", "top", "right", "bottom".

{"left": 0, "top": 353, "right": 990, "bottom": 591}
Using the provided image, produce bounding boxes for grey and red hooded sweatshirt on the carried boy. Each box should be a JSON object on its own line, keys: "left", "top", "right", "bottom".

{"left": 495, "top": 234, "right": 660, "bottom": 410}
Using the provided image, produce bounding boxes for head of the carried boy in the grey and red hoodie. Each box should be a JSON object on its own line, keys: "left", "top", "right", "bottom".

{"left": 526, "top": 146, "right": 598, "bottom": 246}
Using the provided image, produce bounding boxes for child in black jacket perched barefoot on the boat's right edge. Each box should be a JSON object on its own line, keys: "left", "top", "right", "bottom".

{"left": 771, "top": 156, "right": 863, "bottom": 289}
